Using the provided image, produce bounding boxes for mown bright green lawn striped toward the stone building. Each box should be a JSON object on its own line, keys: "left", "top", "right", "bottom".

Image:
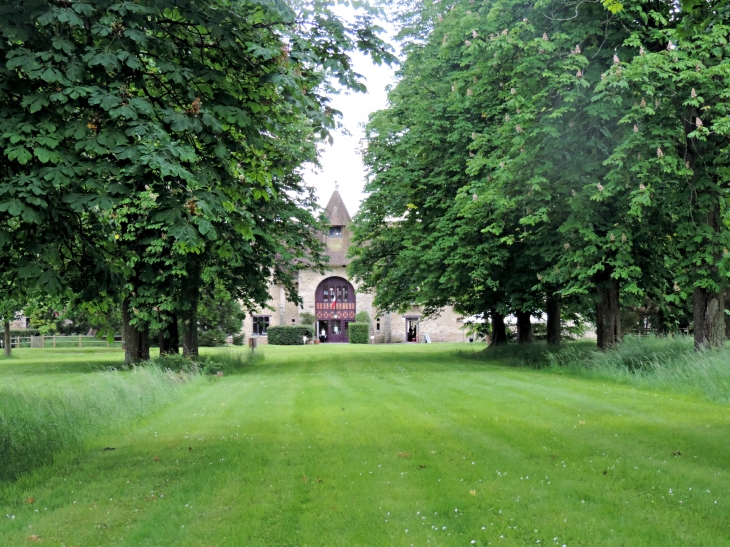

{"left": 0, "top": 344, "right": 730, "bottom": 547}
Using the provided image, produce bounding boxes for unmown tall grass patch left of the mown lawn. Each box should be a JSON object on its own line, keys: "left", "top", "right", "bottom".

{"left": 0, "top": 364, "right": 199, "bottom": 481}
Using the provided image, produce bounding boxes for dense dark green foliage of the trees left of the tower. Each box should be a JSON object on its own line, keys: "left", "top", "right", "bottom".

{"left": 0, "top": 0, "right": 393, "bottom": 361}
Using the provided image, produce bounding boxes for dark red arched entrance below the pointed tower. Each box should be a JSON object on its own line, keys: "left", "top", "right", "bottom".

{"left": 314, "top": 277, "right": 356, "bottom": 342}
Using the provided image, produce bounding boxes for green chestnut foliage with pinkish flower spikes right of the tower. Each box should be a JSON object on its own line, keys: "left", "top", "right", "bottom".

{"left": 350, "top": 0, "right": 730, "bottom": 347}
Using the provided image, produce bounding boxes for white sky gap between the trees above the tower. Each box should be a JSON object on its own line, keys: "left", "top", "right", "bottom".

{"left": 304, "top": 26, "right": 395, "bottom": 216}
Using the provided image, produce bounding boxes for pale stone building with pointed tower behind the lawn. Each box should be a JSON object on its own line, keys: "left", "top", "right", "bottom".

{"left": 243, "top": 190, "right": 465, "bottom": 344}
